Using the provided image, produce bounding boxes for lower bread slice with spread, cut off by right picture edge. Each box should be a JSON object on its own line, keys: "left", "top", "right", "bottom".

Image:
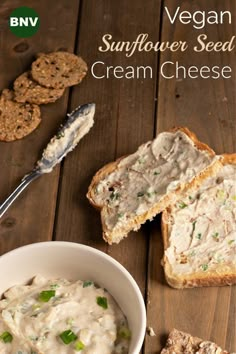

{"left": 162, "top": 154, "right": 236, "bottom": 288}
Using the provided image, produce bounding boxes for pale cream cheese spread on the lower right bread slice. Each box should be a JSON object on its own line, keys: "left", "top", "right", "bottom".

{"left": 165, "top": 165, "right": 236, "bottom": 275}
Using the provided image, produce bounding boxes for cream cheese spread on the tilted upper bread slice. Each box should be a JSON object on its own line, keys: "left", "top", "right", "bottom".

{"left": 93, "top": 130, "right": 214, "bottom": 230}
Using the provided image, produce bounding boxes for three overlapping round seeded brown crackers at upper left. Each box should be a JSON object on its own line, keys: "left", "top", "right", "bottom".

{"left": 0, "top": 52, "right": 88, "bottom": 141}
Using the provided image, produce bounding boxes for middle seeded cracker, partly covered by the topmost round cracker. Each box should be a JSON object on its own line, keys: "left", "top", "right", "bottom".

{"left": 14, "top": 71, "right": 64, "bottom": 104}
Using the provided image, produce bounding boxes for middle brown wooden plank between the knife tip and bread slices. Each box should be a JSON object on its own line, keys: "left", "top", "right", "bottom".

{"left": 55, "top": 0, "right": 160, "bottom": 304}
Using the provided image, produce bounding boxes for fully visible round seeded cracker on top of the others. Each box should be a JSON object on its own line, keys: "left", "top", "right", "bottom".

{"left": 31, "top": 52, "right": 88, "bottom": 89}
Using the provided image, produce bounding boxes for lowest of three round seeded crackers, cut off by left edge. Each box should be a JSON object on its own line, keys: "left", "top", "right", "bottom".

{"left": 0, "top": 90, "right": 41, "bottom": 141}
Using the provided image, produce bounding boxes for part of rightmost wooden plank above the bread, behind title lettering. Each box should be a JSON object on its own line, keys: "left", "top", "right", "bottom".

{"left": 157, "top": 0, "right": 236, "bottom": 154}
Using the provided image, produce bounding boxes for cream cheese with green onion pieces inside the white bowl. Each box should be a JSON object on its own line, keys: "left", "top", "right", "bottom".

{"left": 0, "top": 276, "right": 131, "bottom": 354}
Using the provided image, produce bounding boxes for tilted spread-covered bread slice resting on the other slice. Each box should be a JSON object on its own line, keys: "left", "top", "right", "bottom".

{"left": 87, "top": 128, "right": 221, "bottom": 244}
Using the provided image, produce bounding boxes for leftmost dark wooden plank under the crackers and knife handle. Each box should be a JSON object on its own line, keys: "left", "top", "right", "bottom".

{"left": 0, "top": 0, "right": 79, "bottom": 254}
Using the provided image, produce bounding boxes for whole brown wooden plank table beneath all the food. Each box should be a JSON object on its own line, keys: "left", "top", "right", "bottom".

{"left": 0, "top": 0, "right": 236, "bottom": 354}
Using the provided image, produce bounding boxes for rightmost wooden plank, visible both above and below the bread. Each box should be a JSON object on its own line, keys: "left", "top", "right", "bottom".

{"left": 145, "top": 0, "right": 236, "bottom": 354}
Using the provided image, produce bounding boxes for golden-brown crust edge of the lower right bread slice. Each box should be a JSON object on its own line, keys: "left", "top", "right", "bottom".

{"left": 161, "top": 154, "right": 236, "bottom": 289}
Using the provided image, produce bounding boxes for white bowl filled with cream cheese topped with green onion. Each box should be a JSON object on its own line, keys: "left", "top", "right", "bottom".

{"left": 0, "top": 241, "right": 146, "bottom": 354}
